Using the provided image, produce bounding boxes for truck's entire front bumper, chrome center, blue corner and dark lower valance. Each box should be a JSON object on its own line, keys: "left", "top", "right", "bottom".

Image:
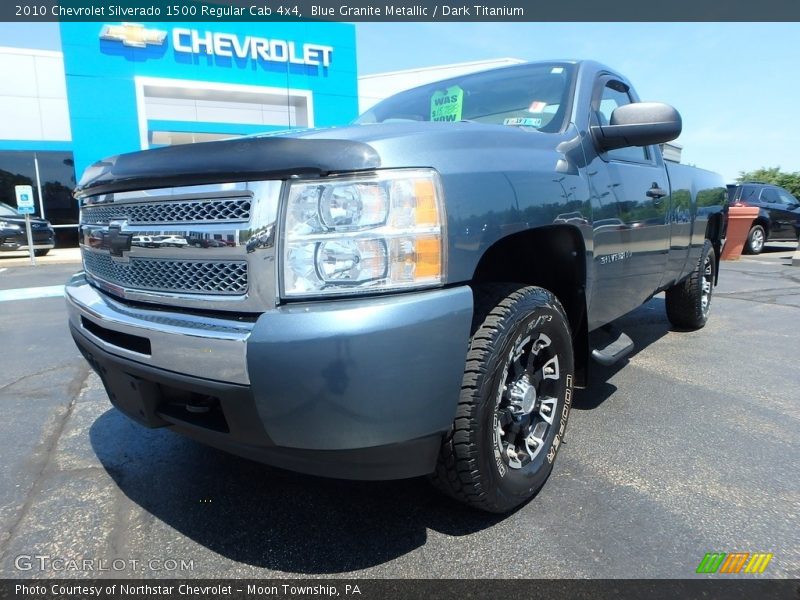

{"left": 66, "top": 275, "right": 472, "bottom": 479}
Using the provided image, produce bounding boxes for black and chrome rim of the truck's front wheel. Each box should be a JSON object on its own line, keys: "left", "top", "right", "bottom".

{"left": 494, "top": 333, "right": 564, "bottom": 469}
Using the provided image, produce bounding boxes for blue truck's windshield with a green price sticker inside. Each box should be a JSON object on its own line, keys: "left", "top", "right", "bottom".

{"left": 356, "top": 63, "right": 574, "bottom": 132}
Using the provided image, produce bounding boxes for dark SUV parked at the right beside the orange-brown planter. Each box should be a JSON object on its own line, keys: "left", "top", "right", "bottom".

{"left": 726, "top": 182, "right": 800, "bottom": 254}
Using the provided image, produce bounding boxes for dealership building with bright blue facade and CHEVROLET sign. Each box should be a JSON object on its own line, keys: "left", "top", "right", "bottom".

{"left": 0, "top": 22, "right": 358, "bottom": 243}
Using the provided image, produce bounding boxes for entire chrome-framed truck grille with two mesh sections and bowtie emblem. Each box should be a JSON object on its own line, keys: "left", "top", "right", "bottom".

{"left": 79, "top": 180, "right": 283, "bottom": 313}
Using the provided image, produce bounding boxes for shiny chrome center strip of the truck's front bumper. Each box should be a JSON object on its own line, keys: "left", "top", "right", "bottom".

{"left": 65, "top": 273, "right": 254, "bottom": 384}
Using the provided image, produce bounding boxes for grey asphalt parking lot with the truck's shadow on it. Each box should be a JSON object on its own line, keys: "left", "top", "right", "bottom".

{"left": 0, "top": 244, "right": 800, "bottom": 578}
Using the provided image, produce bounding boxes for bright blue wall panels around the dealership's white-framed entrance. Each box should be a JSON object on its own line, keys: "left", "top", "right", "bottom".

{"left": 60, "top": 22, "right": 358, "bottom": 177}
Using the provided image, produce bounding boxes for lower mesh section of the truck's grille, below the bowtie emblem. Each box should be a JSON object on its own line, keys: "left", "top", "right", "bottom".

{"left": 83, "top": 250, "right": 247, "bottom": 296}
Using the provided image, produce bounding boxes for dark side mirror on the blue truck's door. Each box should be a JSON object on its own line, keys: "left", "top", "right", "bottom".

{"left": 591, "top": 102, "right": 682, "bottom": 150}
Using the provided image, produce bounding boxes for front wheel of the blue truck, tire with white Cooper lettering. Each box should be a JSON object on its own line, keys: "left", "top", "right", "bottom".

{"left": 430, "top": 284, "right": 574, "bottom": 513}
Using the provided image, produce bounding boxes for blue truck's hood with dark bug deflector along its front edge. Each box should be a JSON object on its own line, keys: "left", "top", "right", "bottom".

{"left": 75, "top": 122, "right": 551, "bottom": 196}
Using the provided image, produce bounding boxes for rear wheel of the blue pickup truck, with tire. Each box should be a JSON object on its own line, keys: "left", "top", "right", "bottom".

{"left": 665, "top": 240, "right": 717, "bottom": 329}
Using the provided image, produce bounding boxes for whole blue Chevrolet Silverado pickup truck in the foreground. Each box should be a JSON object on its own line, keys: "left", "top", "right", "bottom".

{"left": 66, "top": 61, "right": 726, "bottom": 512}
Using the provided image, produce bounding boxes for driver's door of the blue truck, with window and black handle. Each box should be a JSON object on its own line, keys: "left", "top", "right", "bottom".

{"left": 589, "top": 76, "right": 671, "bottom": 326}
